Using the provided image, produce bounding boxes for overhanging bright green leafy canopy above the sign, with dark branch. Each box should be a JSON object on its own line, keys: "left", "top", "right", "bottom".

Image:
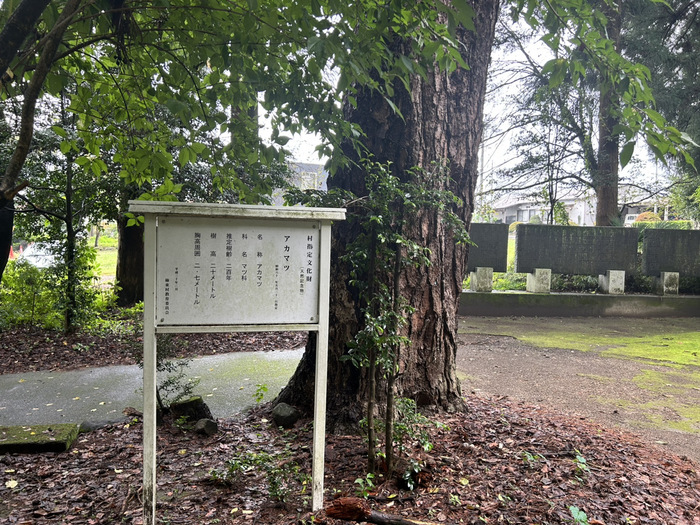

{"left": 0, "top": 0, "right": 468, "bottom": 292}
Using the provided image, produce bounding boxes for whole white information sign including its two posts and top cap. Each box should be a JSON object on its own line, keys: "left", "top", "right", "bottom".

{"left": 129, "top": 201, "right": 345, "bottom": 525}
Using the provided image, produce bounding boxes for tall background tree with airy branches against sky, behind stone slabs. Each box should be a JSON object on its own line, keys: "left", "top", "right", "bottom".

{"left": 484, "top": 2, "right": 690, "bottom": 225}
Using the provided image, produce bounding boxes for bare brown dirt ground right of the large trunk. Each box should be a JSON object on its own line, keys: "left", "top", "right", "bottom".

{"left": 457, "top": 318, "right": 700, "bottom": 464}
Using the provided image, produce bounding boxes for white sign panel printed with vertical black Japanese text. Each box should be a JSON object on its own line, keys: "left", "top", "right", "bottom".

{"left": 156, "top": 216, "right": 321, "bottom": 326}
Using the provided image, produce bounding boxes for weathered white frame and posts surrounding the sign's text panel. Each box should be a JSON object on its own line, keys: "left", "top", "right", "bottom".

{"left": 129, "top": 201, "right": 345, "bottom": 525}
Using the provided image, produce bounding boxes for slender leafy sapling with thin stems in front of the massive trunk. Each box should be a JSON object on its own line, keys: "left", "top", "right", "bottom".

{"left": 326, "top": 160, "right": 468, "bottom": 473}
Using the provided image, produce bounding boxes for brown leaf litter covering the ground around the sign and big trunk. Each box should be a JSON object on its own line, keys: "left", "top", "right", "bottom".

{"left": 0, "top": 326, "right": 700, "bottom": 525}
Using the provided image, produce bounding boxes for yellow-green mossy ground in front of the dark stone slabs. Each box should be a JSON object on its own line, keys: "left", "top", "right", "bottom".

{"left": 460, "top": 317, "right": 700, "bottom": 433}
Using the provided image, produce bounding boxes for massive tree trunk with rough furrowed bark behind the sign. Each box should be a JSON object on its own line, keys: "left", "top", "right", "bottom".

{"left": 278, "top": 0, "right": 498, "bottom": 430}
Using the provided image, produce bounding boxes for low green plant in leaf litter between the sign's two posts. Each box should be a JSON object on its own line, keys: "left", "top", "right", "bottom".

{"left": 209, "top": 448, "right": 309, "bottom": 502}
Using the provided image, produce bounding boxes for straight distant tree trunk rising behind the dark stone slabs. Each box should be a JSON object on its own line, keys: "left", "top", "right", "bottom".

{"left": 593, "top": 6, "right": 622, "bottom": 226}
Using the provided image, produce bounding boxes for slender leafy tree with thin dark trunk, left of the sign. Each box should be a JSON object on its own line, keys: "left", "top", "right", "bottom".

{"left": 8, "top": 96, "right": 116, "bottom": 332}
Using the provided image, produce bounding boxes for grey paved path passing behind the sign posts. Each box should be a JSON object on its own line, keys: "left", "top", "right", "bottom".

{"left": 0, "top": 348, "right": 304, "bottom": 426}
